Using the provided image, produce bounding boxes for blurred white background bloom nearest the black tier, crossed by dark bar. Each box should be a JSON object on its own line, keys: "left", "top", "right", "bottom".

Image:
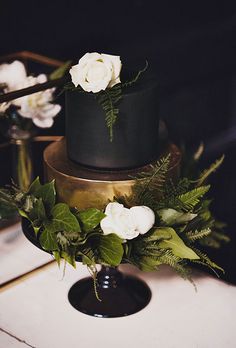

{"left": 13, "top": 74, "right": 61, "bottom": 128}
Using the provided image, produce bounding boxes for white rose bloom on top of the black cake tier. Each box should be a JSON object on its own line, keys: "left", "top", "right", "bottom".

{"left": 70, "top": 52, "right": 121, "bottom": 93}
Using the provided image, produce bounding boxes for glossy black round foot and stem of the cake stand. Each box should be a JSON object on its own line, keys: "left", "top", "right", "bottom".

{"left": 68, "top": 267, "right": 151, "bottom": 318}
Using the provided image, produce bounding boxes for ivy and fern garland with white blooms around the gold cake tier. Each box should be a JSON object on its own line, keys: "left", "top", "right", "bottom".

{"left": 0, "top": 148, "right": 228, "bottom": 294}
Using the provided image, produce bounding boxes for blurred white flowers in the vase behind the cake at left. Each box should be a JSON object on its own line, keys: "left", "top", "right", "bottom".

{"left": 0, "top": 60, "right": 61, "bottom": 130}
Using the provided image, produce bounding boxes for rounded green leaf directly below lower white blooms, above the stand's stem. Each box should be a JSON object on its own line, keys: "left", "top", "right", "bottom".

{"left": 99, "top": 233, "right": 124, "bottom": 267}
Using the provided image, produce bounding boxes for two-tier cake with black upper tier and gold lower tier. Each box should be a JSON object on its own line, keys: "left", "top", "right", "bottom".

{"left": 44, "top": 53, "right": 180, "bottom": 210}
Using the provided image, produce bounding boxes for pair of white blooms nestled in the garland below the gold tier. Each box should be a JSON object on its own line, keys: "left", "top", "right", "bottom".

{"left": 100, "top": 202, "right": 155, "bottom": 239}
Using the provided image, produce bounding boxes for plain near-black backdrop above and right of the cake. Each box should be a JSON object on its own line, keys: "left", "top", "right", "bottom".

{"left": 0, "top": 0, "right": 236, "bottom": 283}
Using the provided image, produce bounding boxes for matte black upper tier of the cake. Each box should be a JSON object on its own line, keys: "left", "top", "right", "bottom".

{"left": 66, "top": 72, "right": 159, "bottom": 169}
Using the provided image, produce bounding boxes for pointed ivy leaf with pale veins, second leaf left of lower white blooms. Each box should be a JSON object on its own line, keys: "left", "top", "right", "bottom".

{"left": 46, "top": 203, "right": 81, "bottom": 232}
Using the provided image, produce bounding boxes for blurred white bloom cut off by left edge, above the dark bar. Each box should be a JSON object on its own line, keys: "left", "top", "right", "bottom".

{"left": 0, "top": 60, "right": 27, "bottom": 92}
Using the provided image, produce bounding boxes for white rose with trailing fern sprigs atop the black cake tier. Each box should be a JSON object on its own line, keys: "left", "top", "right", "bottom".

{"left": 64, "top": 52, "right": 148, "bottom": 142}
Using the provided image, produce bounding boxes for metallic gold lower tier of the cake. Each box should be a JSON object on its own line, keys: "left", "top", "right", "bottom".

{"left": 44, "top": 139, "right": 181, "bottom": 210}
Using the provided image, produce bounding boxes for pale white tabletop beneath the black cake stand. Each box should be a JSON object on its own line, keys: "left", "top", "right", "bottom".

{"left": 0, "top": 223, "right": 236, "bottom": 348}
